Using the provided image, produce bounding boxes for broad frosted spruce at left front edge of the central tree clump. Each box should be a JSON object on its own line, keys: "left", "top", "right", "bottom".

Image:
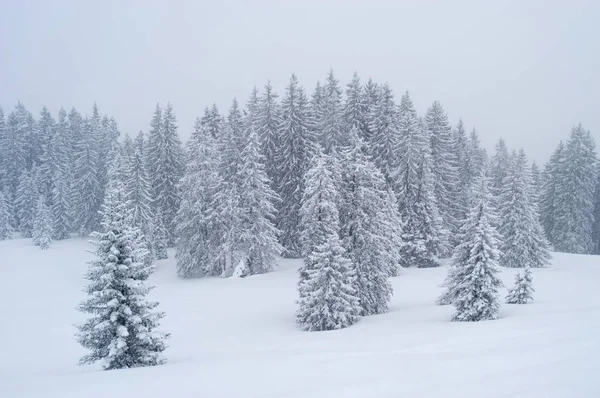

{"left": 175, "top": 117, "right": 223, "bottom": 278}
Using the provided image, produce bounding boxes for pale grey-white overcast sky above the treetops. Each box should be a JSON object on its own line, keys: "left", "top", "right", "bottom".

{"left": 0, "top": 0, "right": 600, "bottom": 161}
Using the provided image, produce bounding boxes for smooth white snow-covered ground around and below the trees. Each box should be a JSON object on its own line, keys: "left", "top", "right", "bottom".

{"left": 0, "top": 239, "right": 600, "bottom": 398}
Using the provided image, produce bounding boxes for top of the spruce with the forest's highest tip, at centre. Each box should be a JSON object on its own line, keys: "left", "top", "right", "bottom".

{"left": 316, "top": 70, "right": 347, "bottom": 153}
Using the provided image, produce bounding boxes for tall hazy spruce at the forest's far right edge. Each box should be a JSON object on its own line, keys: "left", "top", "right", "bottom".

{"left": 550, "top": 124, "right": 598, "bottom": 254}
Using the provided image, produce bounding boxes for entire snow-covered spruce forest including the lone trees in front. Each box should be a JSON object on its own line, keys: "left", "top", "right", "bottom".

{"left": 0, "top": 71, "right": 600, "bottom": 369}
